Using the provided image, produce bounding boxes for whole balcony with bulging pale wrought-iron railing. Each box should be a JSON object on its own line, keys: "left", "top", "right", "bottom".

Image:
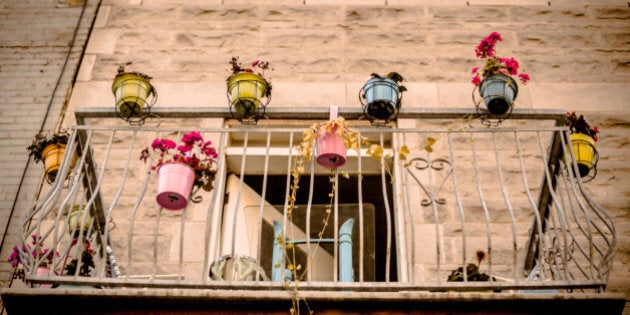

{"left": 2, "top": 109, "right": 624, "bottom": 314}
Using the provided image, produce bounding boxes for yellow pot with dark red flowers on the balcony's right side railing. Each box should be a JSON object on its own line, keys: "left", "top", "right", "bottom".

{"left": 566, "top": 112, "right": 599, "bottom": 177}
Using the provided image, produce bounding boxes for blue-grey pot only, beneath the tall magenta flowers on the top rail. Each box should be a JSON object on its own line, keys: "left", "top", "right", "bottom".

{"left": 479, "top": 73, "right": 518, "bottom": 115}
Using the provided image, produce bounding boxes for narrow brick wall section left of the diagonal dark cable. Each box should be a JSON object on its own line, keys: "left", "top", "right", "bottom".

{"left": 0, "top": 0, "right": 97, "bottom": 292}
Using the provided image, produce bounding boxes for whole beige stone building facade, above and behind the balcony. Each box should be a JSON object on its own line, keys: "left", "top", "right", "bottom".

{"left": 0, "top": 0, "right": 630, "bottom": 315}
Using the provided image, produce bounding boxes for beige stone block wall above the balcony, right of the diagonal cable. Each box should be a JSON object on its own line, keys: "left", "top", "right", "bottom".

{"left": 2, "top": 0, "right": 630, "bottom": 312}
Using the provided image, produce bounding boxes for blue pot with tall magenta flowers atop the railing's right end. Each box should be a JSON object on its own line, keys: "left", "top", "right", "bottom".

{"left": 472, "top": 32, "right": 530, "bottom": 115}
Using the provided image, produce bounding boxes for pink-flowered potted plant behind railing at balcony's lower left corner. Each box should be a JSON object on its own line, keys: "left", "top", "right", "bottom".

{"left": 7, "top": 234, "right": 60, "bottom": 288}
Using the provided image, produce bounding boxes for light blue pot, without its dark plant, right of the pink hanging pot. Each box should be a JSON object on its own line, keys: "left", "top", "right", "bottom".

{"left": 363, "top": 77, "right": 401, "bottom": 120}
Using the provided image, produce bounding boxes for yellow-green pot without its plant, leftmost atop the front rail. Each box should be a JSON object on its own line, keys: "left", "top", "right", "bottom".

{"left": 112, "top": 72, "right": 154, "bottom": 118}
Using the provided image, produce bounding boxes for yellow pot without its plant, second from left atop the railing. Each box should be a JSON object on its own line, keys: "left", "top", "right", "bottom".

{"left": 227, "top": 72, "right": 268, "bottom": 118}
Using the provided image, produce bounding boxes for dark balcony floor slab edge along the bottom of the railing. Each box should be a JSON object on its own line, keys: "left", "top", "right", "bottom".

{"left": 1, "top": 288, "right": 625, "bottom": 315}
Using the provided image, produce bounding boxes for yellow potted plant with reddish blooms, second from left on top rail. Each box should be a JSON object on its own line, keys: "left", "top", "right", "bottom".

{"left": 227, "top": 57, "right": 273, "bottom": 121}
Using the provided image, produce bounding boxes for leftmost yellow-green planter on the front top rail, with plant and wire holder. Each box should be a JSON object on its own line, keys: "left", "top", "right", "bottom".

{"left": 112, "top": 66, "right": 157, "bottom": 124}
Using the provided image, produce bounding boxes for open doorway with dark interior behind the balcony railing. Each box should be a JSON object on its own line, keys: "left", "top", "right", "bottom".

{"left": 220, "top": 121, "right": 397, "bottom": 281}
